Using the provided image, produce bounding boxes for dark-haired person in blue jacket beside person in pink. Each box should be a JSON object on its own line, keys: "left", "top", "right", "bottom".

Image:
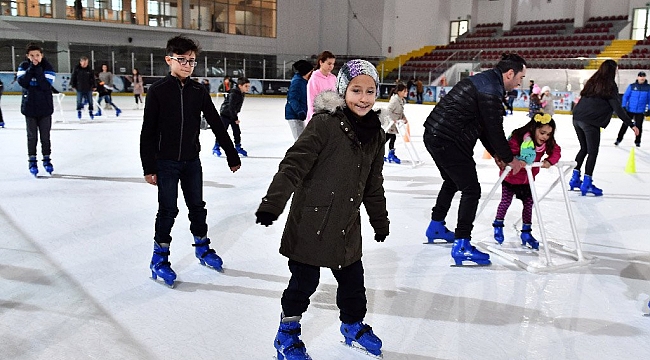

{"left": 284, "top": 60, "right": 314, "bottom": 141}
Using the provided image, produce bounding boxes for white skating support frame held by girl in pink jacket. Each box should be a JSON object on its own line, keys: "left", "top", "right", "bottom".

{"left": 476, "top": 161, "right": 594, "bottom": 273}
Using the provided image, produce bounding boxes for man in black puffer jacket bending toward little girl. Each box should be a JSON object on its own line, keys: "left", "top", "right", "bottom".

{"left": 424, "top": 54, "right": 526, "bottom": 265}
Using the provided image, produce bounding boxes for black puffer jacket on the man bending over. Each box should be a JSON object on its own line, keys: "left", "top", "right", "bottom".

{"left": 424, "top": 68, "right": 513, "bottom": 163}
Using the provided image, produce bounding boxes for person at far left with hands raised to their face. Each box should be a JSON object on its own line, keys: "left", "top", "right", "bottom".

{"left": 16, "top": 43, "right": 56, "bottom": 176}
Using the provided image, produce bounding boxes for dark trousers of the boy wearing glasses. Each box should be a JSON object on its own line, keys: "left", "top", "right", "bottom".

{"left": 154, "top": 158, "right": 208, "bottom": 244}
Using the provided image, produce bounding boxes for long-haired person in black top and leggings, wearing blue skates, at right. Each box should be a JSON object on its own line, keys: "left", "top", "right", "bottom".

{"left": 569, "top": 60, "right": 639, "bottom": 196}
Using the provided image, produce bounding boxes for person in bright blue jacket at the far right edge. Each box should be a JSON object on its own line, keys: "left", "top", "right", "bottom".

{"left": 614, "top": 71, "right": 650, "bottom": 147}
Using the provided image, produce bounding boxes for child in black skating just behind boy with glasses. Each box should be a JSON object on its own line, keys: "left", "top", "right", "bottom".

{"left": 212, "top": 77, "right": 251, "bottom": 157}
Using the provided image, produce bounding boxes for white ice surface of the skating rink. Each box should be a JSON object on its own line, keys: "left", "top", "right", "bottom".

{"left": 0, "top": 95, "right": 650, "bottom": 360}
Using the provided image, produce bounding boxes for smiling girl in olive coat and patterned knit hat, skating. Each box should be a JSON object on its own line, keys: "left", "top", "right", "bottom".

{"left": 255, "top": 59, "right": 388, "bottom": 360}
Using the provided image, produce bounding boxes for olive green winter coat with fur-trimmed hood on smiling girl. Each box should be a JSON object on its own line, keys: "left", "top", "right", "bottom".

{"left": 258, "top": 92, "right": 388, "bottom": 269}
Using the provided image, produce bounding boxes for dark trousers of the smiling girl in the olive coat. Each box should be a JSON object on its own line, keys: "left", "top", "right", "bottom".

{"left": 281, "top": 260, "right": 368, "bottom": 324}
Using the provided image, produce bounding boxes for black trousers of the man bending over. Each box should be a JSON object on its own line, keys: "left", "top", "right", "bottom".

{"left": 424, "top": 130, "right": 481, "bottom": 239}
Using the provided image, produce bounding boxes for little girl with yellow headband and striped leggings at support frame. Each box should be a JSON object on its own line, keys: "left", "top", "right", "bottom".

{"left": 492, "top": 113, "right": 561, "bottom": 250}
